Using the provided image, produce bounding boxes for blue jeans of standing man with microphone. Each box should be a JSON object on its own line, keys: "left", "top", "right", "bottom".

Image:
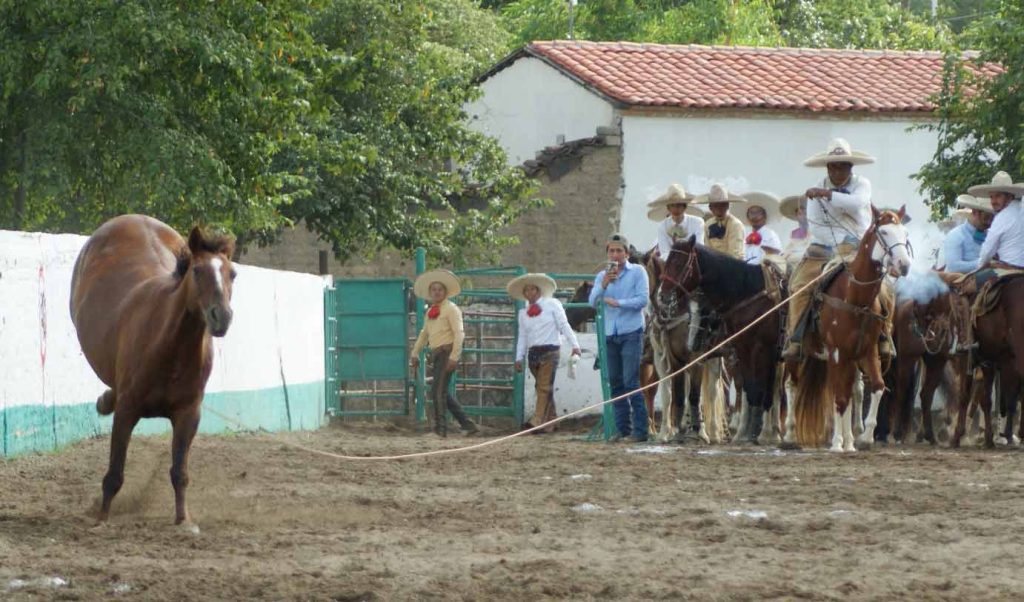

{"left": 604, "top": 330, "right": 647, "bottom": 439}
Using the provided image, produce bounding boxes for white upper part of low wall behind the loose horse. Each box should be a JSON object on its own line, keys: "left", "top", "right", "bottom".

{"left": 0, "top": 230, "right": 325, "bottom": 421}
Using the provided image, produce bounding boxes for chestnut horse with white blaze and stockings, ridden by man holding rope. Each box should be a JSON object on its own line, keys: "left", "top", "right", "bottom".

{"left": 792, "top": 206, "right": 911, "bottom": 452}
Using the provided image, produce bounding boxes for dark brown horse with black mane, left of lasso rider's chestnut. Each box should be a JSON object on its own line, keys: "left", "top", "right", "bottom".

{"left": 662, "top": 237, "right": 785, "bottom": 443}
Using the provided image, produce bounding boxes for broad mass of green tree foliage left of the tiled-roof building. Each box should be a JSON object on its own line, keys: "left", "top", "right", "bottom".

{"left": 0, "top": 0, "right": 540, "bottom": 261}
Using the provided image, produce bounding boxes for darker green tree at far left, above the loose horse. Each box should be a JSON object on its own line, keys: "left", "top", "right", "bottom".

{"left": 0, "top": 0, "right": 315, "bottom": 231}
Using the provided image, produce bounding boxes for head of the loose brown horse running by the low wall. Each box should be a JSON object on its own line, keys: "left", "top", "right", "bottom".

{"left": 177, "top": 226, "right": 236, "bottom": 337}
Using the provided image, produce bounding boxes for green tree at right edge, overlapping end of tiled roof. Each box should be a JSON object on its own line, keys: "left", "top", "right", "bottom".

{"left": 914, "top": 2, "right": 1024, "bottom": 217}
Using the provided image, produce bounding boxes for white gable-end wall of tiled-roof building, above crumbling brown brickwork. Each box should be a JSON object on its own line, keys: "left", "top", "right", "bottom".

{"left": 466, "top": 57, "right": 614, "bottom": 165}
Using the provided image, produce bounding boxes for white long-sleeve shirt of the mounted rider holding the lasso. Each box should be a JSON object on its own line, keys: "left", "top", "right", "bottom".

{"left": 807, "top": 175, "right": 871, "bottom": 247}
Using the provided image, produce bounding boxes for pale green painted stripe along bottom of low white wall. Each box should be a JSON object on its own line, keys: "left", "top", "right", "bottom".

{"left": 0, "top": 381, "right": 327, "bottom": 458}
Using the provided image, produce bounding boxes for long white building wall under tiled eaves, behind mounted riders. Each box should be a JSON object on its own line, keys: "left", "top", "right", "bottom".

{"left": 622, "top": 116, "right": 942, "bottom": 266}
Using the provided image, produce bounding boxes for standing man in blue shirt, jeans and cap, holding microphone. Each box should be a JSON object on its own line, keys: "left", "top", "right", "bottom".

{"left": 590, "top": 234, "right": 648, "bottom": 441}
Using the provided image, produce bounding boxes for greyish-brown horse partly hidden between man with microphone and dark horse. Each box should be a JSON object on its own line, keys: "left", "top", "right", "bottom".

{"left": 644, "top": 249, "right": 719, "bottom": 443}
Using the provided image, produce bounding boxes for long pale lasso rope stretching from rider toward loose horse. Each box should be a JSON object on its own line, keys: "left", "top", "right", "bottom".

{"left": 204, "top": 272, "right": 826, "bottom": 462}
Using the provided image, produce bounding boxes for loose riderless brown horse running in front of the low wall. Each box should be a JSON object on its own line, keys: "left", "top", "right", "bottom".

{"left": 71, "top": 215, "right": 234, "bottom": 530}
